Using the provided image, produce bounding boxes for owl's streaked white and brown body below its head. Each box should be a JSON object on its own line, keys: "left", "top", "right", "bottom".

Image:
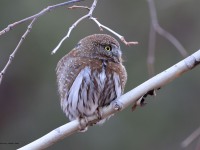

{"left": 57, "top": 58, "right": 124, "bottom": 120}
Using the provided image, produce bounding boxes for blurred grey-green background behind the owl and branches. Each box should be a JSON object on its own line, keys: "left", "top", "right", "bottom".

{"left": 0, "top": 0, "right": 200, "bottom": 150}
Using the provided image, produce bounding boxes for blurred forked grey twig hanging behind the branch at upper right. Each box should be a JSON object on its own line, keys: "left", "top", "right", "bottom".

{"left": 147, "top": 0, "right": 188, "bottom": 75}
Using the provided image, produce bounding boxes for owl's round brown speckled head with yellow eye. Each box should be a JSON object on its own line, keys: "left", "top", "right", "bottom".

{"left": 77, "top": 34, "right": 122, "bottom": 62}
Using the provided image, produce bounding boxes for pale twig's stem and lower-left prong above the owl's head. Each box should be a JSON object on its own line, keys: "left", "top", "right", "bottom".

{"left": 51, "top": 0, "right": 98, "bottom": 54}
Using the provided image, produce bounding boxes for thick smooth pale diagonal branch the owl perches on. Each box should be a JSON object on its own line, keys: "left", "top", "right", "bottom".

{"left": 18, "top": 50, "right": 200, "bottom": 150}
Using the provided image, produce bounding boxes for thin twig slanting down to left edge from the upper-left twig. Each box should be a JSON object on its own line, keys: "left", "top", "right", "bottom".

{"left": 0, "top": 18, "right": 37, "bottom": 84}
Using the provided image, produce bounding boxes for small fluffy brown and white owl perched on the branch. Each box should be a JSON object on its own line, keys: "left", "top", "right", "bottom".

{"left": 56, "top": 34, "right": 127, "bottom": 126}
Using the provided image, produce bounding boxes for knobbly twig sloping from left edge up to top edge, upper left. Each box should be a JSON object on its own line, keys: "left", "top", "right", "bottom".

{"left": 0, "top": 0, "right": 84, "bottom": 36}
